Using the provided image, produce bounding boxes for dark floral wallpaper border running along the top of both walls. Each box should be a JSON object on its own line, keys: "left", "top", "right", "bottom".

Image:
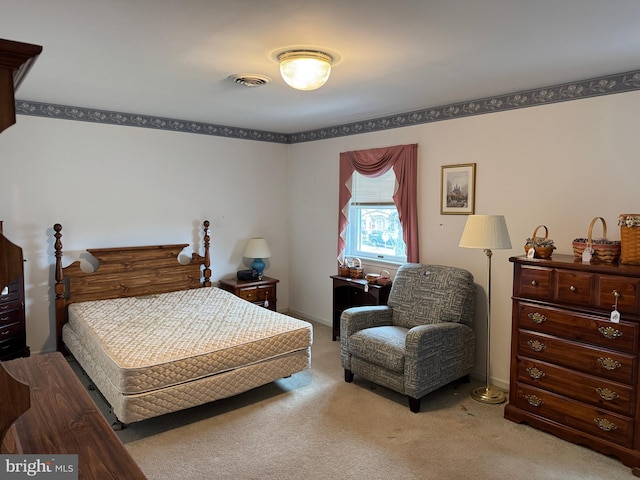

{"left": 16, "top": 70, "right": 640, "bottom": 144}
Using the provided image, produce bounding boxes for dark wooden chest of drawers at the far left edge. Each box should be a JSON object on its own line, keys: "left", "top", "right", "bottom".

{"left": 0, "top": 222, "right": 30, "bottom": 361}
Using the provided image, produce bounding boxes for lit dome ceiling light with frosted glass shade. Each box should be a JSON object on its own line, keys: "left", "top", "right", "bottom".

{"left": 278, "top": 50, "right": 333, "bottom": 90}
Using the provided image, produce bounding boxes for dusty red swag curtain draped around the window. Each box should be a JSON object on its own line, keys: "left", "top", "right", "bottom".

{"left": 338, "top": 144, "right": 419, "bottom": 263}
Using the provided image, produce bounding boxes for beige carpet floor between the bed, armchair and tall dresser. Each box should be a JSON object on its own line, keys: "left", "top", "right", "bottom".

{"left": 72, "top": 325, "right": 633, "bottom": 480}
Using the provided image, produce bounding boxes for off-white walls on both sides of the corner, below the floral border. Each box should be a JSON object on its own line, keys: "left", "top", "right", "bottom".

{"left": 0, "top": 92, "right": 640, "bottom": 386}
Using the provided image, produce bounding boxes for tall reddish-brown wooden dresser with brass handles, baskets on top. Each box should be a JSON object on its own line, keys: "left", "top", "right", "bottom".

{"left": 504, "top": 255, "right": 640, "bottom": 476}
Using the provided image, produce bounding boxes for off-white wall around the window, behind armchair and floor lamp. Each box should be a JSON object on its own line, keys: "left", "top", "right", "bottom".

{"left": 289, "top": 92, "right": 640, "bottom": 387}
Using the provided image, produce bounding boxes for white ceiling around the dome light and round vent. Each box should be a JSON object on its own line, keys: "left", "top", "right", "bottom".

{"left": 0, "top": 0, "right": 640, "bottom": 133}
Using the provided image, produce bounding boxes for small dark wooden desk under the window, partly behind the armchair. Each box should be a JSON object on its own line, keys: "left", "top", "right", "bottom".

{"left": 331, "top": 275, "right": 391, "bottom": 340}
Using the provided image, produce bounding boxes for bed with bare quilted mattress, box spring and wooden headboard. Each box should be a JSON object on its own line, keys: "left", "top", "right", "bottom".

{"left": 54, "top": 221, "right": 313, "bottom": 424}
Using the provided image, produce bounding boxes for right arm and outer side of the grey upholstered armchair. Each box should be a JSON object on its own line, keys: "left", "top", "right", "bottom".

{"left": 404, "top": 322, "right": 475, "bottom": 398}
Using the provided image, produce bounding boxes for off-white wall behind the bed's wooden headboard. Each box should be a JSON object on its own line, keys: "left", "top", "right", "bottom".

{"left": 0, "top": 116, "right": 289, "bottom": 353}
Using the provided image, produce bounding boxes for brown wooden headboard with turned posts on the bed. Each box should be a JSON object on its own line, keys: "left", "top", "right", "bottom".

{"left": 53, "top": 220, "right": 211, "bottom": 353}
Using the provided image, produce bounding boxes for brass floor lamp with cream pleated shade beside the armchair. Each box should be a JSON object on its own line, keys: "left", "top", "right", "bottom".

{"left": 459, "top": 215, "right": 511, "bottom": 403}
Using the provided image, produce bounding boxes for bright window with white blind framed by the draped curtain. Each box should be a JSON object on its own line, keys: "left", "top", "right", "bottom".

{"left": 345, "top": 169, "right": 407, "bottom": 262}
